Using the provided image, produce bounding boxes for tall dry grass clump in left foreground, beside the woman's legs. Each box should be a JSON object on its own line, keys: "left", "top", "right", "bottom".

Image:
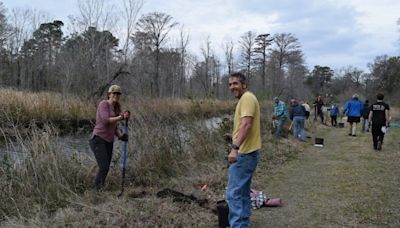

{"left": 0, "top": 123, "right": 90, "bottom": 219}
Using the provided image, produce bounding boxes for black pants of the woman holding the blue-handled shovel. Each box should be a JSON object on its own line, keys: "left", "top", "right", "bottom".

{"left": 89, "top": 135, "right": 113, "bottom": 188}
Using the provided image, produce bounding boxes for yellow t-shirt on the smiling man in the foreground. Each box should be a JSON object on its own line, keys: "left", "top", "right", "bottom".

{"left": 232, "top": 91, "right": 261, "bottom": 154}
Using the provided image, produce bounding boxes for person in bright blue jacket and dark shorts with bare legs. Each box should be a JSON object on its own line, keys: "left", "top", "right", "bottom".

{"left": 343, "top": 94, "right": 364, "bottom": 136}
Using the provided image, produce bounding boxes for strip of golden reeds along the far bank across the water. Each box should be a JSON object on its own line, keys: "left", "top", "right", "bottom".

{"left": 0, "top": 89, "right": 234, "bottom": 133}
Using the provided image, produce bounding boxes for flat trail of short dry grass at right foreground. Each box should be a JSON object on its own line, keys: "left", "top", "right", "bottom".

{"left": 252, "top": 124, "right": 400, "bottom": 227}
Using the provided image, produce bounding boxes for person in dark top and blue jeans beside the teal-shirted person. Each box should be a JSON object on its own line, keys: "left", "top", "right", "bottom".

{"left": 289, "top": 99, "right": 306, "bottom": 142}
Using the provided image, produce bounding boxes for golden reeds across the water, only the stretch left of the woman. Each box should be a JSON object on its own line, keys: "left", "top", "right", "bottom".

{"left": 0, "top": 89, "right": 95, "bottom": 132}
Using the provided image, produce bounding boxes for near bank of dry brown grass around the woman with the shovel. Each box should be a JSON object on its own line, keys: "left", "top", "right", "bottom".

{"left": 0, "top": 89, "right": 299, "bottom": 227}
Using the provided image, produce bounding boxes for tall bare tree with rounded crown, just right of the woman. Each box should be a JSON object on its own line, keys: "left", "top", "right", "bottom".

{"left": 136, "top": 12, "right": 178, "bottom": 97}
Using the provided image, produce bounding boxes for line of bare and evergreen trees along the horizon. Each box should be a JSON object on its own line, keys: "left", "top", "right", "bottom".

{"left": 0, "top": 0, "right": 400, "bottom": 104}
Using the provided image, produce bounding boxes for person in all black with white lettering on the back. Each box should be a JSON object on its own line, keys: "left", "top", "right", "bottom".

{"left": 369, "top": 93, "right": 390, "bottom": 150}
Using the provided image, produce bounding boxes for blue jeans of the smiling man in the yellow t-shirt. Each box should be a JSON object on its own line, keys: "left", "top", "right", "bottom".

{"left": 226, "top": 150, "right": 260, "bottom": 227}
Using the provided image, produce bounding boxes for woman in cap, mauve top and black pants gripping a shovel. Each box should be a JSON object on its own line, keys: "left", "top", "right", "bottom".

{"left": 89, "top": 85, "right": 129, "bottom": 189}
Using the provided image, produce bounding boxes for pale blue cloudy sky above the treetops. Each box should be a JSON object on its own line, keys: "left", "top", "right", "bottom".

{"left": 0, "top": 0, "right": 400, "bottom": 72}
